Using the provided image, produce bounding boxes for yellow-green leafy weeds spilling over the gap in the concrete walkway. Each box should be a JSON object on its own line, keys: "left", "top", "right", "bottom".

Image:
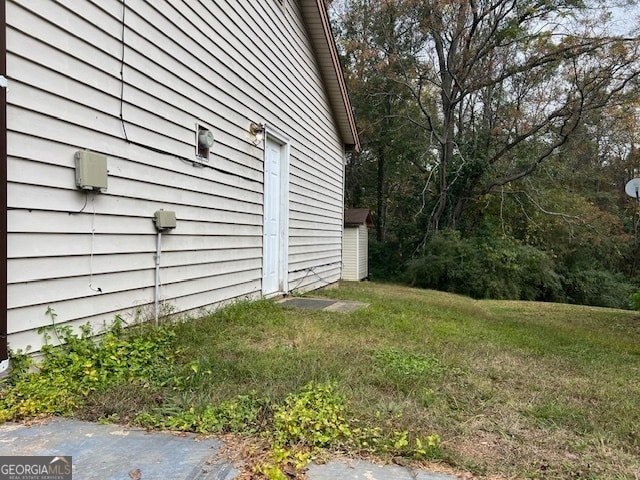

{"left": 133, "top": 380, "right": 441, "bottom": 480}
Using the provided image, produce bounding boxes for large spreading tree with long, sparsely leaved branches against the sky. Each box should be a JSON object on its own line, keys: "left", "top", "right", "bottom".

{"left": 340, "top": 0, "right": 639, "bottom": 246}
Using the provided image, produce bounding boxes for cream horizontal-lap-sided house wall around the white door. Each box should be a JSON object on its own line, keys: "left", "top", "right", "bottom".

{"left": 6, "top": 0, "right": 343, "bottom": 350}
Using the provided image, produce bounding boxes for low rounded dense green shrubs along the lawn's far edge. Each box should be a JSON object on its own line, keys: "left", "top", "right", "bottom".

{"left": 405, "top": 230, "right": 637, "bottom": 308}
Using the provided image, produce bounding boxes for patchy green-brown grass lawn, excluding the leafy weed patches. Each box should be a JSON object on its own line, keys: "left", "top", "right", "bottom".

{"left": 71, "top": 283, "right": 640, "bottom": 480}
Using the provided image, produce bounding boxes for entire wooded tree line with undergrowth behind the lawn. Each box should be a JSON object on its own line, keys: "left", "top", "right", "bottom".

{"left": 331, "top": 0, "right": 640, "bottom": 307}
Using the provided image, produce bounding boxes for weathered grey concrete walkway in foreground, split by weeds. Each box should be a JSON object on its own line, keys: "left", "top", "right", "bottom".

{"left": 0, "top": 418, "right": 455, "bottom": 480}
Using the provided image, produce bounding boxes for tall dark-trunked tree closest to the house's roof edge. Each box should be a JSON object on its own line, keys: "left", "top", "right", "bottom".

{"left": 338, "top": 1, "right": 422, "bottom": 241}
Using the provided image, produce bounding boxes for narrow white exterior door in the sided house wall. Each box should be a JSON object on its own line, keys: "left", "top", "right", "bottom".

{"left": 262, "top": 137, "right": 287, "bottom": 295}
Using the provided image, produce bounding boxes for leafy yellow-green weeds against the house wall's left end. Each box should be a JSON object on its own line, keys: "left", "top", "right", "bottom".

{"left": 0, "top": 308, "right": 175, "bottom": 422}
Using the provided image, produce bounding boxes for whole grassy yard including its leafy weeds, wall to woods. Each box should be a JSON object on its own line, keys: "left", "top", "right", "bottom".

{"left": 0, "top": 283, "right": 640, "bottom": 479}
